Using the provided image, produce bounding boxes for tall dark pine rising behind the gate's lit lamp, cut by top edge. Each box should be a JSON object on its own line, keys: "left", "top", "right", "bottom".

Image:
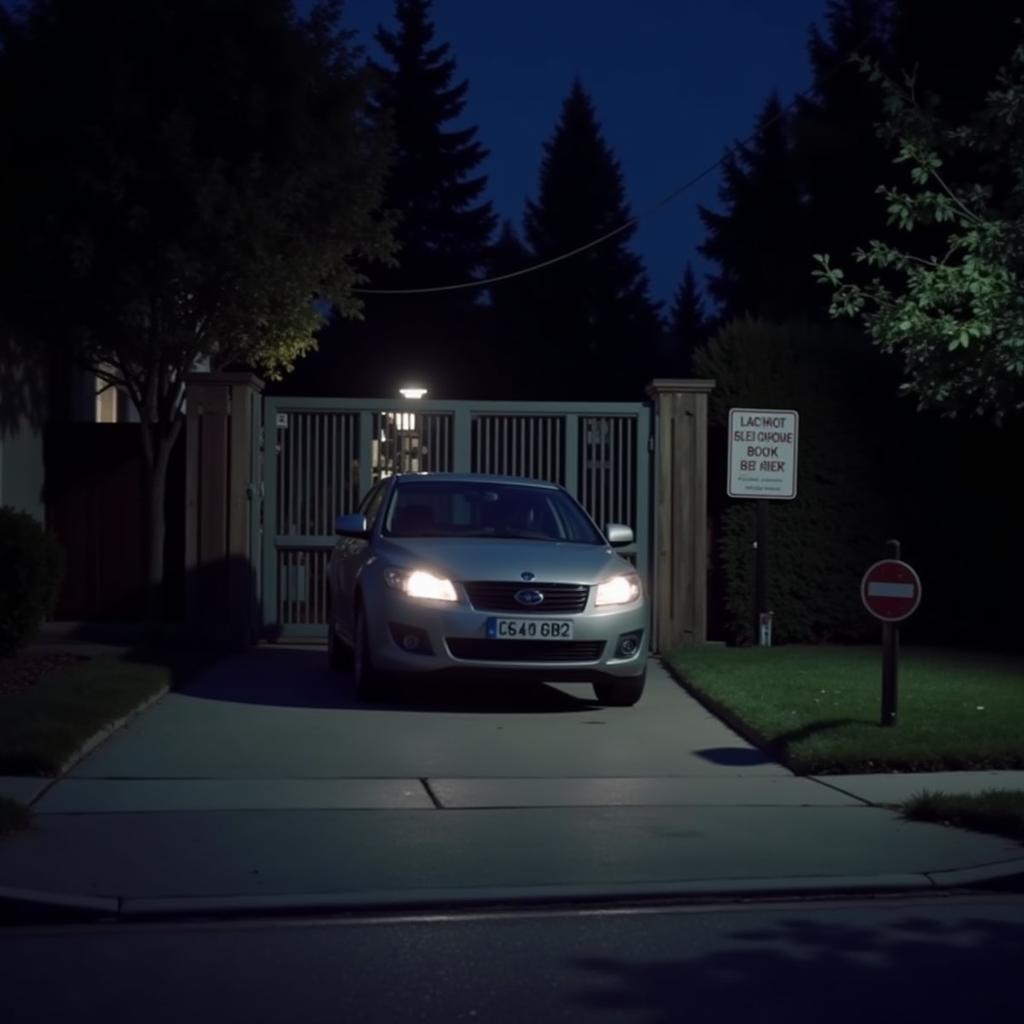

{"left": 276, "top": 0, "right": 496, "bottom": 398}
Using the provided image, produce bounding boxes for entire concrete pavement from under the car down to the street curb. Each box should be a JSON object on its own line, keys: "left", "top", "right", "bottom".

{"left": 0, "top": 650, "right": 1024, "bottom": 916}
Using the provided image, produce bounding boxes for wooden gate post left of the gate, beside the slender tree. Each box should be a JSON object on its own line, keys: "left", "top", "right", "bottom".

{"left": 185, "top": 373, "right": 263, "bottom": 648}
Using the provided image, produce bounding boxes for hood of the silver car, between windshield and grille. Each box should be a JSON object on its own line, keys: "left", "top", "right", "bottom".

{"left": 378, "top": 537, "right": 633, "bottom": 585}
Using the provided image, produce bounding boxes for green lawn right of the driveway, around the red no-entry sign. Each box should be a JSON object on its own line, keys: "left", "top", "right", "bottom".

{"left": 666, "top": 646, "right": 1024, "bottom": 774}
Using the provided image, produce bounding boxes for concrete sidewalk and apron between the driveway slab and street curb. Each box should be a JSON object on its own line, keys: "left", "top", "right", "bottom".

{"left": 0, "top": 772, "right": 1024, "bottom": 916}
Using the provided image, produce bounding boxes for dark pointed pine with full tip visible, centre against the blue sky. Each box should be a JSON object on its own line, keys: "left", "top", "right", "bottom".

{"left": 523, "top": 81, "right": 660, "bottom": 400}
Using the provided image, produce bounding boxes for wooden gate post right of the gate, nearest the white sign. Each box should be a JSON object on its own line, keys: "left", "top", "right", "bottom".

{"left": 647, "top": 380, "right": 715, "bottom": 651}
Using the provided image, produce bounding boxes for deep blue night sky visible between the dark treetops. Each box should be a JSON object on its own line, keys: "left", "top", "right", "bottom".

{"left": 331, "top": 0, "right": 826, "bottom": 305}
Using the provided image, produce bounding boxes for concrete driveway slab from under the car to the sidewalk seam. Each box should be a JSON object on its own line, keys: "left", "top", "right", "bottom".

{"left": 64, "top": 647, "right": 791, "bottom": 779}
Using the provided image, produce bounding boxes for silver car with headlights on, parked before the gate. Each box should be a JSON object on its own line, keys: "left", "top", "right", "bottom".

{"left": 328, "top": 473, "right": 648, "bottom": 706}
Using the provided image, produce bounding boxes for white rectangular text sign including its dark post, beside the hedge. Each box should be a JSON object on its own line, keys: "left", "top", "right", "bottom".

{"left": 726, "top": 409, "right": 800, "bottom": 647}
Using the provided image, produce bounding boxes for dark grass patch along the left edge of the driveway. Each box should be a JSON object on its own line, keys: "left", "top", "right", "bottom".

{"left": 0, "top": 657, "right": 184, "bottom": 775}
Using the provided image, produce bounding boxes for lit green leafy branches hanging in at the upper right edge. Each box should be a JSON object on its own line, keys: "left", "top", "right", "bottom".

{"left": 816, "top": 36, "right": 1024, "bottom": 420}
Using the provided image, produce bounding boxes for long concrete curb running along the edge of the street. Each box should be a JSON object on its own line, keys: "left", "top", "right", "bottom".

{"left": 0, "top": 857, "right": 1024, "bottom": 923}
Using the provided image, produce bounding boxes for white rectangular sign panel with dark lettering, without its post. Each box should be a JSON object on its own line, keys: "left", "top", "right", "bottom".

{"left": 728, "top": 409, "right": 800, "bottom": 500}
